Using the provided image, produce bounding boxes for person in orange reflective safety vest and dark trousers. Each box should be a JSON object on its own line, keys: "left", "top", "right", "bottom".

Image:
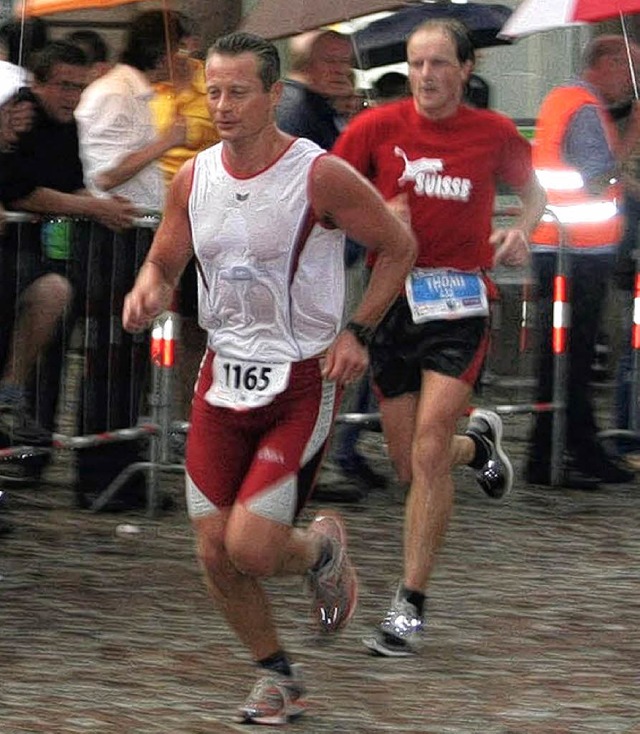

{"left": 526, "top": 35, "right": 640, "bottom": 488}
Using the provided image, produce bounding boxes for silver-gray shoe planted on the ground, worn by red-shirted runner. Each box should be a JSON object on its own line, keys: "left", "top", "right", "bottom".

{"left": 362, "top": 594, "right": 424, "bottom": 658}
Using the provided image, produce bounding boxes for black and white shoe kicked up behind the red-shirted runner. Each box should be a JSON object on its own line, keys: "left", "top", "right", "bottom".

{"left": 466, "top": 408, "right": 513, "bottom": 499}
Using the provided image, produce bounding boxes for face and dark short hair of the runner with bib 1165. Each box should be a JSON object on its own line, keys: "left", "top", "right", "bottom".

{"left": 206, "top": 53, "right": 280, "bottom": 142}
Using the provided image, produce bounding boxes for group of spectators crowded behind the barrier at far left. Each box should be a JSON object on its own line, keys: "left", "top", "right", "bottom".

{"left": 0, "top": 11, "right": 211, "bottom": 509}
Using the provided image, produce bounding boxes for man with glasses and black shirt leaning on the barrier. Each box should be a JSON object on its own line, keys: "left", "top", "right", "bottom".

{"left": 0, "top": 42, "right": 135, "bottom": 460}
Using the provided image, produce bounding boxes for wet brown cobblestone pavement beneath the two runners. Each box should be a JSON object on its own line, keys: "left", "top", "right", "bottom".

{"left": 0, "top": 402, "right": 640, "bottom": 734}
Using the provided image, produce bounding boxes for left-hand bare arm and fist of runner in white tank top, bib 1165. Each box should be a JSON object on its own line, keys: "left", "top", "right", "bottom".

{"left": 122, "top": 161, "right": 193, "bottom": 331}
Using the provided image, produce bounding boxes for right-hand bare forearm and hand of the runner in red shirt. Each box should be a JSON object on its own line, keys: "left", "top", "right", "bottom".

{"left": 489, "top": 174, "right": 547, "bottom": 267}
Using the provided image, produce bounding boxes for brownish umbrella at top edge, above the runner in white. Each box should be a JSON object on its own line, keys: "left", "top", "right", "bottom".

{"left": 240, "top": 0, "right": 411, "bottom": 39}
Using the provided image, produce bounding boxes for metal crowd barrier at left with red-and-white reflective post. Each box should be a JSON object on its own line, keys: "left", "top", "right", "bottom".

{"left": 0, "top": 212, "right": 185, "bottom": 514}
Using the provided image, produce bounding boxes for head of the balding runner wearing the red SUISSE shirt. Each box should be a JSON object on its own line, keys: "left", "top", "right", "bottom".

{"left": 407, "top": 28, "right": 472, "bottom": 120}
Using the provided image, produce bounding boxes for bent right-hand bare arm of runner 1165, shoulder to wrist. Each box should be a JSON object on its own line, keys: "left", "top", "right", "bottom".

{"left": 310, "top": 155, "right": 416, "bottom": 326}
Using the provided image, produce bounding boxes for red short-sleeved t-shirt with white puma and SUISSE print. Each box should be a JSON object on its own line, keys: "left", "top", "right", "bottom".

{"left": 331, "top": 99, "right": 532, "bottom": 270}
